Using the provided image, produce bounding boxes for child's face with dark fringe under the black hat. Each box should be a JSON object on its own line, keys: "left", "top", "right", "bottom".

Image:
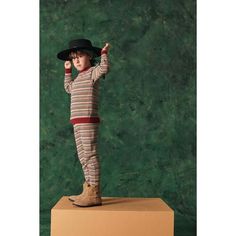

{"left": 70, "top": 51, "right": 92, "bottom": 71}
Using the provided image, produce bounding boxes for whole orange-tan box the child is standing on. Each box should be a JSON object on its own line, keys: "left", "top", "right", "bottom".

{"left": 51, "top": 196, "right": 174, "bottom": 236}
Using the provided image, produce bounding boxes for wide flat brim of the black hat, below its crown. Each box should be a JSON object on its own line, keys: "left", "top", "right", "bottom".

{"left": 57, "top": 47, "right": 102, "bottom": 61}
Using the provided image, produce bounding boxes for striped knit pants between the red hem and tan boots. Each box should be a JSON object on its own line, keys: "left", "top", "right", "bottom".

{"left": 73, "top": 123, "right": 100, "bottom": 185}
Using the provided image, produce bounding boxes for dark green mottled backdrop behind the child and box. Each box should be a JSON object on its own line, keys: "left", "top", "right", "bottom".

{"left": 40, "top": 0, "right": 196, "bottom": 236}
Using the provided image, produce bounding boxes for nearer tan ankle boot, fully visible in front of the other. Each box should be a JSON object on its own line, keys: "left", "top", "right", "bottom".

{"left": 73, "top": 184, "right": 102, "bottom": 207}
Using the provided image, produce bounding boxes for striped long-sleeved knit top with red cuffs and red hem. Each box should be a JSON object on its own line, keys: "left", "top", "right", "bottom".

{"left": 64, "top": 52, "right": 109, "bottom": 124}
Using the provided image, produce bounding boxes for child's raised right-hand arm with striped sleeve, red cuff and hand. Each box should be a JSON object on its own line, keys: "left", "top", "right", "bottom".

{"left": 92, "top": 43, "right": 109, "bottom": 83}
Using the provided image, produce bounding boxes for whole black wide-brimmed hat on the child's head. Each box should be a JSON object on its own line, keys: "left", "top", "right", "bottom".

{"left": 57, "top": 39, "right": 102, "bottom": 61}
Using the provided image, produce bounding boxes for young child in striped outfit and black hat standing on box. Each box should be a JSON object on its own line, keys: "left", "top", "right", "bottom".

{"left": 57, "top": 39, "right": 109, "bottom": 206}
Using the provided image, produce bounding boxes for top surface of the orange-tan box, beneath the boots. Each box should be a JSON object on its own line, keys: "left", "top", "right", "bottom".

{"left": 52, "top": 196, "right": 173, "bottom": 212}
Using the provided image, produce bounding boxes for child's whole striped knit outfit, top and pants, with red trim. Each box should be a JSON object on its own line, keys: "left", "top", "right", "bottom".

{"left": 64, "top": 53, "right": 108, "bottom": 185}
